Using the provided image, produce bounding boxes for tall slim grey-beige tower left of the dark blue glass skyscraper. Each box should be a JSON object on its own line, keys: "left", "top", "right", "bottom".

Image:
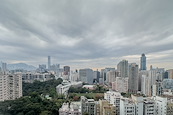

{"left": 128, "top": 63, "right": 139, "bottom": 93}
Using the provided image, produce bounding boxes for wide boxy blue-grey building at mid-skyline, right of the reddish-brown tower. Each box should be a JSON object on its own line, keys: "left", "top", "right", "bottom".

{"left": 79, "top": 69, "right": 93, "bottom": 84}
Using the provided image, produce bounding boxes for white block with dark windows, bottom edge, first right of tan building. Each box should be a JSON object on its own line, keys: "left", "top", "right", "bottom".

{"left": 120, "top": 98, "right": 136, "bottom": 115}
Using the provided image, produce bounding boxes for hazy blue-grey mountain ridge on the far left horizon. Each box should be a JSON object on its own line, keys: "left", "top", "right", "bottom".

{"left": 7, "top": 63, "right": 36, "bottom": 71}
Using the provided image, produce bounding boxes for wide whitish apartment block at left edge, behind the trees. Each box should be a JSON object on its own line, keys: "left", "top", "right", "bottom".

{"left": 0, "top": 73, "right": 22, "bottom": 101}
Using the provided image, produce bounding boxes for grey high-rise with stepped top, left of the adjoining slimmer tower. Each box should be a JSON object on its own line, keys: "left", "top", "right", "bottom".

{"left": 117, "top": 60, "right": 128, "bottom": 77}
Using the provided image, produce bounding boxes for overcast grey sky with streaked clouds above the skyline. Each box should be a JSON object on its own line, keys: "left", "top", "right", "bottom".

{"left": 0, "top": 0, "right": 173, "bottom": 69}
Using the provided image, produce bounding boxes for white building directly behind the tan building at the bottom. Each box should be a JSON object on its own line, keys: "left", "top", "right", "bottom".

{"left": 104, "top": 91, "right": 122, "bottom": 115}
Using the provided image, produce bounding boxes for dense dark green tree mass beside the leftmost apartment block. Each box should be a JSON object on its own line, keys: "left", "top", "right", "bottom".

{"left": 0, "top": 79, "right": 65, "bottom": 115}
